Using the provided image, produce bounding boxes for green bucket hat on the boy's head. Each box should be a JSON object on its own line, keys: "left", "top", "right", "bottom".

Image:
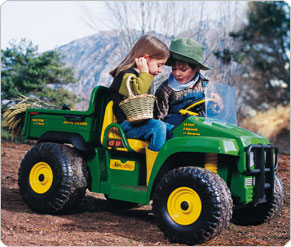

{"left": 166, "top": 38, "right": 209, "bottom": 70}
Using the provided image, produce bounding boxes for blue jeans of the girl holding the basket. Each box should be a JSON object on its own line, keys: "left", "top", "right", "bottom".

{"left": 121, "top": 119, "right": 174, "bottom": 151}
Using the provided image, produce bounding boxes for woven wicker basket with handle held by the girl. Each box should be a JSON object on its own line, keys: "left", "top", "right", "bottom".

{"left": 119, "top": 75, "right": 156, "bottom": 123}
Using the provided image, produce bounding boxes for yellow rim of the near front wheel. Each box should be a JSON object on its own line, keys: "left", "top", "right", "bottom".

{"left": 167, "top": 187, "right": 202, "bottom": 225}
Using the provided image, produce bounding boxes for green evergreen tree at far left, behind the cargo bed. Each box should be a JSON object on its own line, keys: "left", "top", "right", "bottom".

{"left": 1, "top": 39, "right": 77, "bottom": 105}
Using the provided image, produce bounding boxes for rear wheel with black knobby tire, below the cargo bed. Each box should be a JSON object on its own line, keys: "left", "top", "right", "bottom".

{"left": 18, "top": 142, "right": 88, "bottom": 214}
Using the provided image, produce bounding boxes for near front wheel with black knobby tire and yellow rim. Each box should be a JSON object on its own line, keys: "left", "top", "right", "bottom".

{"left": 153, "top": 167, "right": 232, "bottom": 245}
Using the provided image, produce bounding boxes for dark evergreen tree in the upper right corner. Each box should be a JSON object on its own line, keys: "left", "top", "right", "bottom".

{"left": 216, "top": 1, "right": 290, "bottom": 106}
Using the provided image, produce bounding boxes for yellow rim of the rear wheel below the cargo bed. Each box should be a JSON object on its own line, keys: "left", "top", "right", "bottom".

{"left": 29, "top": 162, "right": 53, "bottom": 194}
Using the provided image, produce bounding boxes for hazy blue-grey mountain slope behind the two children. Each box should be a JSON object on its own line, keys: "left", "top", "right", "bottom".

{"left": 57, "top": 24, "right": 242, "bottom": 110}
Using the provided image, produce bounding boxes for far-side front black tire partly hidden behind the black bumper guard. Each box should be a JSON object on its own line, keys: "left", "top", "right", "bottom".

{"left": 231, "top": 173, "right": 286, "bottom": 226}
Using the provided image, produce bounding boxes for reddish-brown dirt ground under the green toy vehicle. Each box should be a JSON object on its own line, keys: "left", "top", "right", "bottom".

{"left": 1, "top": 142, "right": 290, "bottom": 246}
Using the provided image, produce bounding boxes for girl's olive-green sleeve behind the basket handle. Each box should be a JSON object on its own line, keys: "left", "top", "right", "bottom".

{"left": 119, "top": 72, "right": 154, "bottom": 96}
